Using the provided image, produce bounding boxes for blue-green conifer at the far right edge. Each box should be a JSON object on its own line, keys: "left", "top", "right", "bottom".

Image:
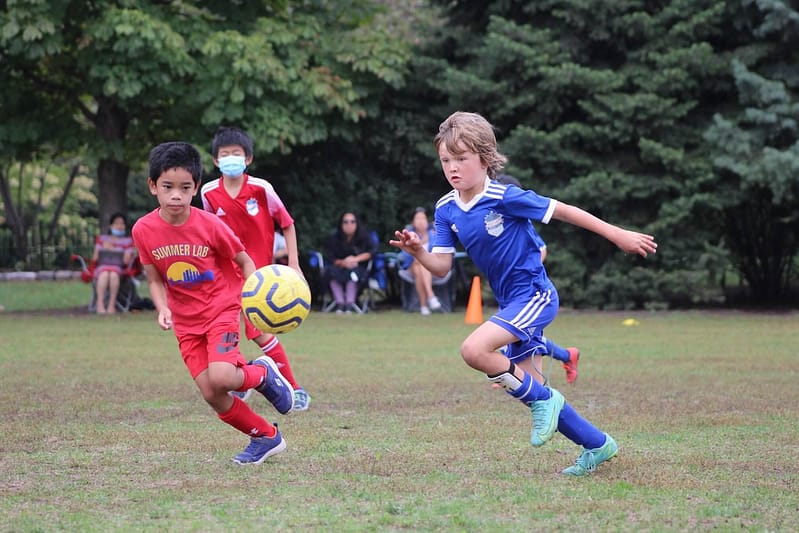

{"left": 705, "top": 1, "right": 799, "bottom": 304}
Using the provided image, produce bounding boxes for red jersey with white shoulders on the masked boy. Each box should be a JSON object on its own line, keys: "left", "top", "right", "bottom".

{"left": 200, "top": 174, "right": 294, "bottom": 268}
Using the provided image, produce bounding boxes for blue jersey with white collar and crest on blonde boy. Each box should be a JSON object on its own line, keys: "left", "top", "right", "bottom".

{"left": 431, "top": 178, "right": 557, "bottom": 307}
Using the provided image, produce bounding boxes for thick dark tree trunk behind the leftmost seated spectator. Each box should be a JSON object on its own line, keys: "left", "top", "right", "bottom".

{"left": 95, "top": 96, "right": 130, "bottom": 233}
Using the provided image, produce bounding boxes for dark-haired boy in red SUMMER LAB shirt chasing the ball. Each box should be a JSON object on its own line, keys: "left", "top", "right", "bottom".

{"left": 133, "top": 142, "right": 294, "bottom": 464}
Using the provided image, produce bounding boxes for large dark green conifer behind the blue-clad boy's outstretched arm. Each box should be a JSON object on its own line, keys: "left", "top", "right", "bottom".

{"left": 415, "top": 0, "right": 752, "bottom": 307}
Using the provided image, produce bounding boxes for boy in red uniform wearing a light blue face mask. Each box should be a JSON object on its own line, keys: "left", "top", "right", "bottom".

{"left": 200, "top": 127, "right": 311, "bottom": 411}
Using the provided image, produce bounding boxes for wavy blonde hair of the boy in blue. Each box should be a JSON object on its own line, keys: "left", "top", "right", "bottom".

{"left": 433, "top": 111, "right": 508, "bottom": 179}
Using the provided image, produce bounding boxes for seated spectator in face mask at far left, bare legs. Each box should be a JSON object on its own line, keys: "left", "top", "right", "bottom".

{"left": 92, "top": 213, "right": 136, "bottom": 315}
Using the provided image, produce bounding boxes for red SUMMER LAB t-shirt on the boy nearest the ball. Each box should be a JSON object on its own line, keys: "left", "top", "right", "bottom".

{"left": 132, "top": 207, "right": 244, "bottom": 334}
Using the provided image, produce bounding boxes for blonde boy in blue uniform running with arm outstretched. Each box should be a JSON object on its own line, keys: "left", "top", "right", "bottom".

{"left": 389, "top": 112, "right": 657, "bottom": 476}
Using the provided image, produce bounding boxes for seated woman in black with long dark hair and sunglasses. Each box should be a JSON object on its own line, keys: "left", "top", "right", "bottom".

{"left": 324, "top": 211, "right": 376, "bottom": 313}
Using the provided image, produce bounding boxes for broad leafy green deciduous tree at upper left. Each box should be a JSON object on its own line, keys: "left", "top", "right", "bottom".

{"left": 0, "top": 0, "right": 408, "bottom": 233}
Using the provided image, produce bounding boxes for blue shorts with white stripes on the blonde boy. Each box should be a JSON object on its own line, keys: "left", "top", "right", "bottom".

{"left": 489, "top": 285, "right": 560, "bottom": 363}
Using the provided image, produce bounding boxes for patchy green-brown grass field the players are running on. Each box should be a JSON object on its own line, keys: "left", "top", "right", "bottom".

{"left": 0, "top": 302, "right": 799, "bottom": 531}
